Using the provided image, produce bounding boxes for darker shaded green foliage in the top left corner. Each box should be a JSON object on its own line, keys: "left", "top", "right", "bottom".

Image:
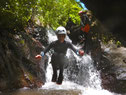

{"left": 0, "top": 0, "right": 36, "bottom": 29}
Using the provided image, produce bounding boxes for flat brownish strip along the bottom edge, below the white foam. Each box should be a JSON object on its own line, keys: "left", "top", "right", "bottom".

{"left": 0, "top": 89, "right": 81, "bottom": 95}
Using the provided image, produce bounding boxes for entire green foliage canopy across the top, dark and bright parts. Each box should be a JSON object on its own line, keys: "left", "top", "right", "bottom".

{"left": 0, "top": 0, "right": 81, "bottom": 29}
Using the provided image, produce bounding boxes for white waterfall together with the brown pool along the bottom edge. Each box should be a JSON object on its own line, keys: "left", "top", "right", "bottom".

{"left": 0, "top": 28, "right": 120, "bottom": 95}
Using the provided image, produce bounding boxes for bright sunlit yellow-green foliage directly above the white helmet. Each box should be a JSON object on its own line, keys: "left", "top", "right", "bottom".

{"left": 37, "top": 0, "right": 81, "bottom": 29}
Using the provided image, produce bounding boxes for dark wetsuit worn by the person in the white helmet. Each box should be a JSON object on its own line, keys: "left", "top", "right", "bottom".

{"left": 44, "top": 40, "right": 78, "bottom": 84}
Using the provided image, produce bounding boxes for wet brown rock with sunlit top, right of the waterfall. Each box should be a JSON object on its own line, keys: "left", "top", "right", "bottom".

{"left": 100, "top": 47, "right": 126, "bottom": 94}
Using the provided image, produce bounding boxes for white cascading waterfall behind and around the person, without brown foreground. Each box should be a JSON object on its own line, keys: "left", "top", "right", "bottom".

{"left": 41, "top": 30, "right": 115, "bottom": 95}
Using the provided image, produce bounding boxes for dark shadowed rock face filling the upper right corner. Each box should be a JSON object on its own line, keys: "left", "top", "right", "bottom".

{"left": 81, "top": 0, "right": 126, "bottom": 45}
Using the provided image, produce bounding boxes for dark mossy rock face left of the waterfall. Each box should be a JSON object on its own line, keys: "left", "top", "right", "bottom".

{"left": 0, "top": 26, "right": 46, "bottom": 91}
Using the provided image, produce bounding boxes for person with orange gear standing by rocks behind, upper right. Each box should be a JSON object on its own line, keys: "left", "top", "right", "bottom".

{"left": 78, "top": 11, "right": 91, "bottom": 54}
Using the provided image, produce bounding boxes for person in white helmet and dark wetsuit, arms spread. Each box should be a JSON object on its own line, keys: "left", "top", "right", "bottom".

{"left": 36, "top": 26, "right": 84, "bottom": 84}
